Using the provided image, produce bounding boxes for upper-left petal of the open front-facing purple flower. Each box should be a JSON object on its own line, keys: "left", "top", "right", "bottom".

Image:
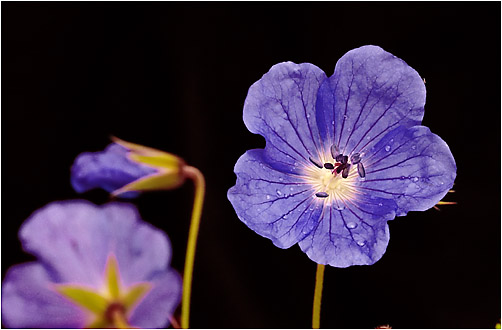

{"left": 244, "top": 62, "right": 326, "bottom": 173}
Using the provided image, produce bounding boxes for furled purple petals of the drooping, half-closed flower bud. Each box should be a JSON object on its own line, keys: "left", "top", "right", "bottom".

{"left": 71, "top": 143, "right": 156, "bottom": 198}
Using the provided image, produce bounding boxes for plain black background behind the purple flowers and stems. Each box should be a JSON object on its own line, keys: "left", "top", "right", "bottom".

{"left": 1, "top": 2, "right": 501, "bottom": 328}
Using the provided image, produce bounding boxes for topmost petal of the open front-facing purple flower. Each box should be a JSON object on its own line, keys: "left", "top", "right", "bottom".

{"left": 316, "top": 46, "right": 425, "bottom": 155}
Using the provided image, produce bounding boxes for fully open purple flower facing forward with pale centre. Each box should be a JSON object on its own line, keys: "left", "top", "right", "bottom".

{"left": 228, "top": 46, "right": 456, "bottom": 267}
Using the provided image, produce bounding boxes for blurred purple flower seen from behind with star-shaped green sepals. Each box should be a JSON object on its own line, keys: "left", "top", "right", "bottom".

{"left": 2, "top": 200, "right": 181, "bottom": 328}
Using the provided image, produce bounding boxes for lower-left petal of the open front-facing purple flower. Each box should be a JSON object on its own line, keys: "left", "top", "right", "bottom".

{"left": 228, "top": 149, "right": 322, "bottom": 248}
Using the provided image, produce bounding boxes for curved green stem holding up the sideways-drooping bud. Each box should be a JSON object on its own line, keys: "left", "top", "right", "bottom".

{"left": 181, "top": 166, "right": 206, "bottom": 329}
